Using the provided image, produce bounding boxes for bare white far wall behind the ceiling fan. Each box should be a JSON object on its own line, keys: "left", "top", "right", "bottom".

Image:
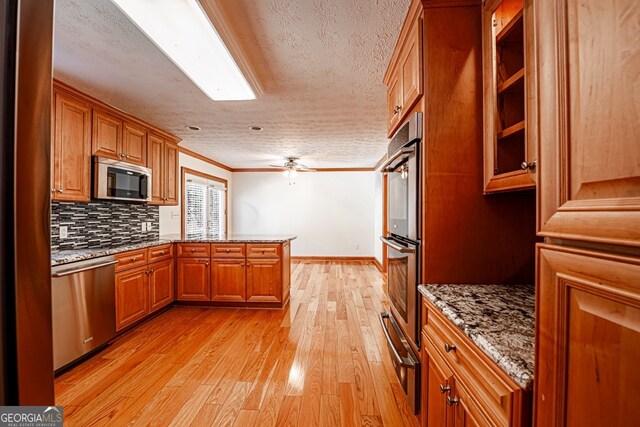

{"left": 233, "top": 172, "right": 379, "bottom": 257}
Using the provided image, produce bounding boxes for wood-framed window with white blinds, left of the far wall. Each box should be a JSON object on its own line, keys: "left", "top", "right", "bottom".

{"left": 182, "top": 168, "right": 227, "bottom": 237}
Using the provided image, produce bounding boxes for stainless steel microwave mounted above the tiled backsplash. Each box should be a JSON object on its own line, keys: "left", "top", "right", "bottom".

{"left": 93, "top": 157, "right": 151, "bottom": 202}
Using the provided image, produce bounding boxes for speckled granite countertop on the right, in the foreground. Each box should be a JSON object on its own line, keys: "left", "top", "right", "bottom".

{"left": 418, "top": 285, "right": 535, "bottom": 390}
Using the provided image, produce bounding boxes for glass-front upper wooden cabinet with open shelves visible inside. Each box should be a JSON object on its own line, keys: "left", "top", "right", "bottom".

{"left": 482, "top": 0, "right": 538, "bottom": 193}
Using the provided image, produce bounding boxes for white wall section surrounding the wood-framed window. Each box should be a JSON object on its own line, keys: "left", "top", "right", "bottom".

{"left": 160, "top": 153, "right": 233, "bottom": 236}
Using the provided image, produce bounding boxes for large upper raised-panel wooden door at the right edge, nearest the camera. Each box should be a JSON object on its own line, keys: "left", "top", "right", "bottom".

{"left": 535, "top": 0, "right": 640, "bottom": 247}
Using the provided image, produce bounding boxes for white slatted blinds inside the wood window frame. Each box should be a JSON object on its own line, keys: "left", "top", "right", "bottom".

{"left": 185, "top": 179, "right": 227, "bottom": 236}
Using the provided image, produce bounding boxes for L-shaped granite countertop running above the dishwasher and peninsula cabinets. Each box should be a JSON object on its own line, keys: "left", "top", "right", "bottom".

{"left": 51, "top": 234, "right": 296, "bottom": 266}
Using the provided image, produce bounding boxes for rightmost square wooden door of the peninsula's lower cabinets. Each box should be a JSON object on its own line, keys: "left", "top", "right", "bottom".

{"left": 247, "top": 259, "right": 282, "bottom": 302}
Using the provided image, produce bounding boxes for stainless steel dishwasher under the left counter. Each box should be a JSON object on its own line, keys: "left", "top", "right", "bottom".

{"left": 51, "top": 256, "right": 116, "bottom": 370}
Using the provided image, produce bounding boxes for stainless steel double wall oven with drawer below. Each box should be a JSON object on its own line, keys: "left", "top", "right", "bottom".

{"left": 380, "top": 113, "right": 422, "bottom": 413}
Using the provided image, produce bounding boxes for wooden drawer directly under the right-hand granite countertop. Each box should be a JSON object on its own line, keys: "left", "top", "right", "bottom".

{"left": 423, "top": 299, "right": 520, "bottom": 425}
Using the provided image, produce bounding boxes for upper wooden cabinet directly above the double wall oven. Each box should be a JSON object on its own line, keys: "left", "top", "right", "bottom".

{"left": 384, "top": 0, "right": 423, "bottom": 137}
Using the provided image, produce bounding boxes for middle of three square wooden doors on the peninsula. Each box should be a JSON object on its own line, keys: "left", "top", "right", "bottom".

{"left": 211, "top": 258, "right": 246, "bottom": 302}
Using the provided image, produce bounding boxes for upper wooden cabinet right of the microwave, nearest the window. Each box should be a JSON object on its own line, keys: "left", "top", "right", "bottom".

{"left": 147, "top": 132, "right": 178, "bottom": 206}
